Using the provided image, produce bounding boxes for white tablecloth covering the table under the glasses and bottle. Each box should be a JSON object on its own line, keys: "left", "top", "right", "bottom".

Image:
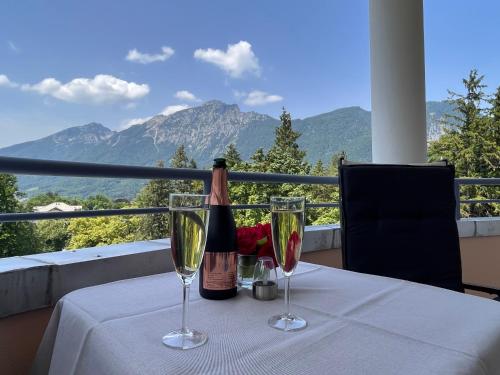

{"left": 33, "top": 263, "right": 500, "bottom": 375}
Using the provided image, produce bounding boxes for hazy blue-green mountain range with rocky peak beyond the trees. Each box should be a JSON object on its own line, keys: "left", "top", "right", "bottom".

{"left": 0, "top": 100, "right": 451, "bottom": 198}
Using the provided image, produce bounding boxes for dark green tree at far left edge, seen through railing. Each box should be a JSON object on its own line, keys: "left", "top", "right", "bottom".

{"left": 0, "top": 174, "right": 39, "bottom": 257}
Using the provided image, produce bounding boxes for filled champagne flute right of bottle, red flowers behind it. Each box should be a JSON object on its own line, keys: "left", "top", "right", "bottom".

{"left": 268, "top": 197, "right": 307, "bottom": 331}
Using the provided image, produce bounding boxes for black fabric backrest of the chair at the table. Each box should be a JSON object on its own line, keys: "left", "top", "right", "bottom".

{"left": 339, "top": 160, "right": 463, "bottom": 292}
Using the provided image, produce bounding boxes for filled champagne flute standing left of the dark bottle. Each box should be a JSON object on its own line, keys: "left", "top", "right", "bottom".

{"left": 163, "top": 194, "right": 209, "bottom": 349}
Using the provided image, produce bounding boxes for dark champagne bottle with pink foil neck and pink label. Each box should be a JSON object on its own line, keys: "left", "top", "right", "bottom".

{"left": 199, "top": 158, "right": 238, "bottom": 299}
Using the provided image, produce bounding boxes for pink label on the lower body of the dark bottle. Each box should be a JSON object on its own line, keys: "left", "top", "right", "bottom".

{"left": 203, "top": 251, "right": 238, "bottom": 290}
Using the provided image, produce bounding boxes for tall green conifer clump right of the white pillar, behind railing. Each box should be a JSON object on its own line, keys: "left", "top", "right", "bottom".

{"left": 429, "top": 70, "right": 500, "bottom": 216}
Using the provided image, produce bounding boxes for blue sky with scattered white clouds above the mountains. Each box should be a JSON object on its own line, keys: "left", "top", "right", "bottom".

{"left": 0, "top": 0, "right": 500, "bottom": 147}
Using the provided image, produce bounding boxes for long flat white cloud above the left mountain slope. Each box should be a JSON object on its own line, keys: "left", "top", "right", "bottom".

{"left": 21, "top": 74, "right": 149, "bottom": 104}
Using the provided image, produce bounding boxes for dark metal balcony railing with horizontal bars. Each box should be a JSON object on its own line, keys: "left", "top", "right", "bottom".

{"left": 0, "top": 156, "right": 500, "bottom": 222}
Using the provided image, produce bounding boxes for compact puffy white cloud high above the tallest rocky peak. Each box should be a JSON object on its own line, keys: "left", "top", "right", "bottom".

{"left": 194, "top": 40, "right": 261, "bottom": 78}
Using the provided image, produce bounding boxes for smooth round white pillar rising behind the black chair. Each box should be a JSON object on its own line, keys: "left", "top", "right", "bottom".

{"left": 370, "top": 0, "right": 427, "bottom": 164}
